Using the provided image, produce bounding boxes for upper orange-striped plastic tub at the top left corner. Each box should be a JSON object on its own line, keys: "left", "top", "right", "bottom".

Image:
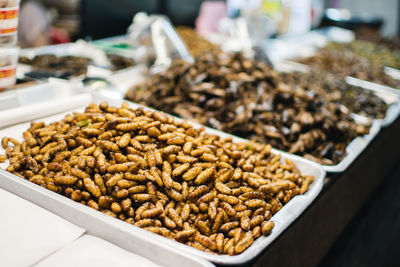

{"left": 0, "top": 0, "right": 20, "bottom": 46}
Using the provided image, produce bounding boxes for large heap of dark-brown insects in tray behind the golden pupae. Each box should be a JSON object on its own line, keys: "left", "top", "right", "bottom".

{"left": 126, "top": 52, "right": 369, "bottom": 165}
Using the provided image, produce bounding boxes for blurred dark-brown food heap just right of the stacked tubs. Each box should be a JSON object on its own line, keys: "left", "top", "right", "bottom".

{"left": 19, "top": 54, "right": 91, "bottom": 76}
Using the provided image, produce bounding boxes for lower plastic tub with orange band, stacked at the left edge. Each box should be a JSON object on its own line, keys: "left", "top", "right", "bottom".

{"left": 0, "top": 47, "right": 19, "bottom": 92}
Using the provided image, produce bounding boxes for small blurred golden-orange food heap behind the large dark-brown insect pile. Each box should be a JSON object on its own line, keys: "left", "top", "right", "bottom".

{"left": 176, "top": 26, "right": 221, "bottom": 57}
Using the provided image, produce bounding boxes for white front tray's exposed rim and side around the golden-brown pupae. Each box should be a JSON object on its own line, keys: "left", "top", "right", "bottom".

{"left": 0, "top": 96, "right": 325, "bottom": 266}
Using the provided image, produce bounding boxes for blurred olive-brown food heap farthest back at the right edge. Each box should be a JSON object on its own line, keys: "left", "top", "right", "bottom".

{"left": 296, "top": 41, "right": 400, "bottom": 88}
